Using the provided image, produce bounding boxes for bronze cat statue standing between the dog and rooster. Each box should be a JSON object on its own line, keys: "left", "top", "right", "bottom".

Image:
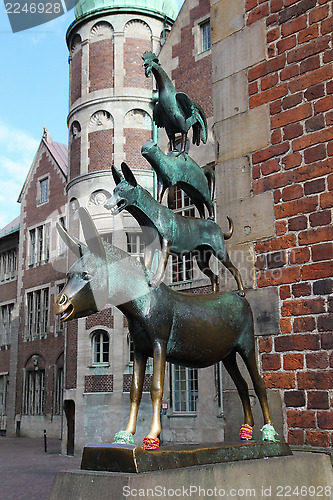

{"left": 141, "top": 141, "right": 214, "bottom": 219}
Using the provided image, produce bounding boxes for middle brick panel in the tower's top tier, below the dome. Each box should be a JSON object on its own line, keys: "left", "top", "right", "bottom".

{"left": 89, "top": 39, "right": 114, "bottom": 92}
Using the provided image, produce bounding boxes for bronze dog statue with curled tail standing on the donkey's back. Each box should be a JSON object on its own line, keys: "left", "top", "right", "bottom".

{"left": 104, "top": 163, "right": 245, "bottom": 295}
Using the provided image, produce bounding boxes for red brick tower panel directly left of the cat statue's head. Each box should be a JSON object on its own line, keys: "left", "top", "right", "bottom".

{"left": 124, "top": 128, "right": 152, "bottom": 170}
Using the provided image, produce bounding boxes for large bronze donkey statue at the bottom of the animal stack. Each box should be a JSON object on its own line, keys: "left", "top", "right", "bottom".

{"left": 55, "top": 208, "right": 275, "bottom": 450}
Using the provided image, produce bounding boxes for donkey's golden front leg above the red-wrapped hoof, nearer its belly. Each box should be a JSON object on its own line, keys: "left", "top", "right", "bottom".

{"left": 147, "top": 342, "right": 166, "bottom": 439}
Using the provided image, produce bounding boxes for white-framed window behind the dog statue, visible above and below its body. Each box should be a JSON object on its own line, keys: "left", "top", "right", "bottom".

{"left": 171, "top": 187, "right": 195, "bottom": 283}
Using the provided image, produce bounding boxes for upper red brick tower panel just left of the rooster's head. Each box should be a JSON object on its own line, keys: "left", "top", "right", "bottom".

{"left": 124, "top": 37, "right": 152, "bottom": 89}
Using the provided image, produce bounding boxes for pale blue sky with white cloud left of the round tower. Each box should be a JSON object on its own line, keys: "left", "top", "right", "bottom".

{"left": 0, "top": 0, "right": 183, "bottom": 229}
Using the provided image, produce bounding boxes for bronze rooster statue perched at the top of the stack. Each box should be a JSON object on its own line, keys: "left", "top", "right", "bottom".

{"left": 142, "top": 52, "right": 207, "bottom": 153}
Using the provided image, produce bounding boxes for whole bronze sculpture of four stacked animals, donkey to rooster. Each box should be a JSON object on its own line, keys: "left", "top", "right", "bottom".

{"left": 55, "top": 52, "right": 276, "bottom": 450}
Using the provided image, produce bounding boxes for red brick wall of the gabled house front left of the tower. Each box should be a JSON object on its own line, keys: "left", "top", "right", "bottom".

{"left": 16, "top": 144, "right": 67, "bottom": 406}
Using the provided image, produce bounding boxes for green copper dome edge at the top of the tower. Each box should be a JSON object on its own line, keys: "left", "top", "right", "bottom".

{"left": 75, "top": 0, "right": 178, "bottom": 20}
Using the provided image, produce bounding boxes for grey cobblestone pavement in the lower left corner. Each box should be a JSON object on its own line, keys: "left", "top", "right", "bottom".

{"left": 0, "top": 437, "right": 81, "bottom": 500}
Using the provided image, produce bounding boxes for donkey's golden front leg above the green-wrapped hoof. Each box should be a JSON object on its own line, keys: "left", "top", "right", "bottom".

{"left": 126, "top": 352, "right": 147, "bottom": 434}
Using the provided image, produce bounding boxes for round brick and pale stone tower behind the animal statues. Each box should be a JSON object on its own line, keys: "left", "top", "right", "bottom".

{"left": 63, "top": 0, "right": 178, "bottom": 452}
